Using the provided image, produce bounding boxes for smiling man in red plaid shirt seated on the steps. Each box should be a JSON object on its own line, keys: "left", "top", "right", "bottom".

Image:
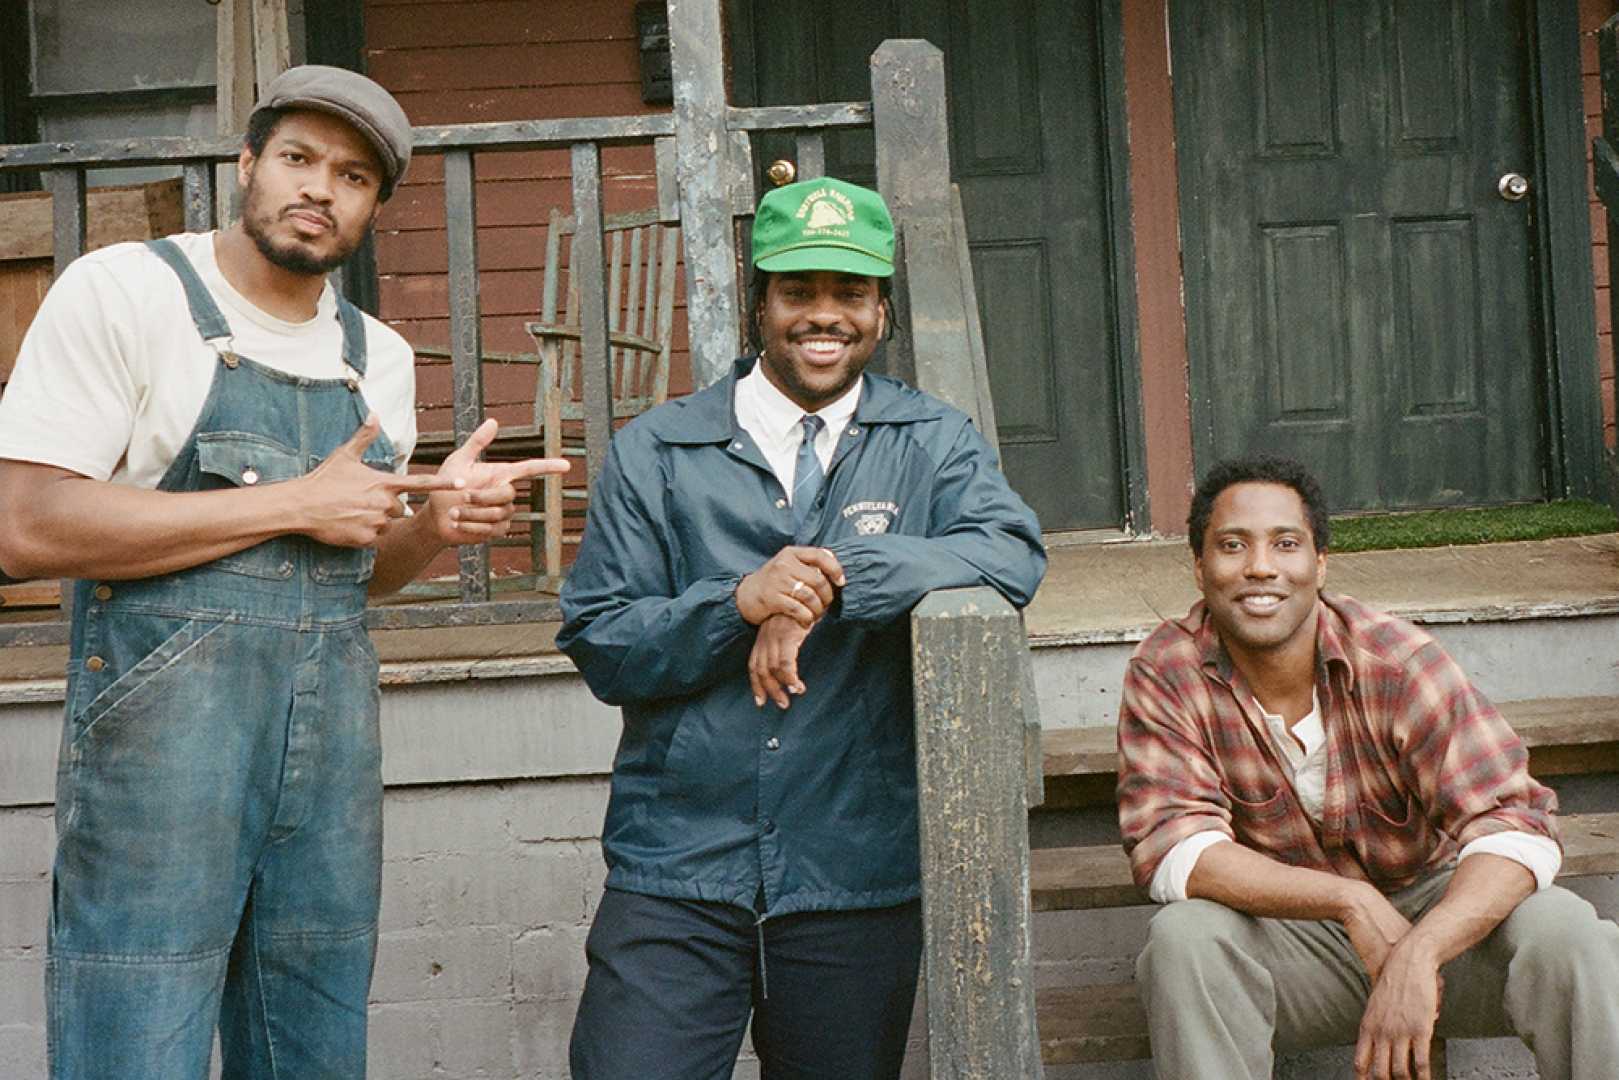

{"left": 1119, "top": 458, "right": 1619, "bottom": 1080}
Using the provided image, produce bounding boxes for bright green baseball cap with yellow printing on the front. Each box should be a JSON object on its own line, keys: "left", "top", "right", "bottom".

{"left": 753, "top": 176, "right": 894, "bottom": 277}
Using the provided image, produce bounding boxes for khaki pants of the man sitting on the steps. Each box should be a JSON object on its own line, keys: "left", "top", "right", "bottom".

{"left": 1137, "top": 871, "right": 1619, "bottom": 1080}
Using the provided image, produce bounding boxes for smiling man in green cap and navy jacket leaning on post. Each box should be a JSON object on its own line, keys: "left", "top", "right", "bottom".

{"left": 557, "top": 180, "right": 1046, "bottom": 1080}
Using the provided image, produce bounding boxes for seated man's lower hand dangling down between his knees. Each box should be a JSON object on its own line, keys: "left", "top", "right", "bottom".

{"left": 1355, "top": 938, "right": 1444, "bottom": 1080}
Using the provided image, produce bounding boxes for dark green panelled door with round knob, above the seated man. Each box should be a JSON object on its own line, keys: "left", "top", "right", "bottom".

{"left": 1171, "top": 0, "right": 1545, "bottom": 508}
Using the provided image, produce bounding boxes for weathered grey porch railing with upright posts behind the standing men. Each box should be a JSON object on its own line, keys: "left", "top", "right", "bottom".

{"left": 0, "top": 40, "right": 994, "bottom": 634}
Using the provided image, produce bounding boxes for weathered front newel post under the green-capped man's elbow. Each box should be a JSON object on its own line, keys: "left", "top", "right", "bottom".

{"left": 911, "top": 588, "right": 1043, "bottom": 1080}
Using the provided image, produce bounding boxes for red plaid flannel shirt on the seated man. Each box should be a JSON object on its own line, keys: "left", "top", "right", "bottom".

{"left": 1119, "top": 594, "right": 1557, "bottom": 892}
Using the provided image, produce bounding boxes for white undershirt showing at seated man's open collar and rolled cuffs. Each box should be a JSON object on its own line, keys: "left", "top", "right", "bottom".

{"left": 1146, "top": 693, "right": 1562, "bottom": 904}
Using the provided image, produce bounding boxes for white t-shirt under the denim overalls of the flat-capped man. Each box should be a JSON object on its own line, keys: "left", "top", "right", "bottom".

{"left": 0, "top": 233, "right": 416, "bottom": 487}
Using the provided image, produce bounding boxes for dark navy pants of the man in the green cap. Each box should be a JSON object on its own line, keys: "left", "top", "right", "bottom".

{"left": 570, "top": 889, "right": 921, "bottom": 1080}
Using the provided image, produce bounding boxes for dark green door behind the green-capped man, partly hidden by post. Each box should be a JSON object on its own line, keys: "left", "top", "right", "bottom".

{"left": 732, "top": 0, "right": 1125, "bottom": 529}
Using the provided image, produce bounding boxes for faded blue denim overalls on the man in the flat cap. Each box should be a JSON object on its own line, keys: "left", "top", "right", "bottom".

{"left": 45, "top": 240, "right": 393, "bottom": 1080}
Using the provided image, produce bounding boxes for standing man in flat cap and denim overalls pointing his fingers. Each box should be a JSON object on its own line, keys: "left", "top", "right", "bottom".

{"left": 0, "top": 66, "right": 567, "bottom": 1080}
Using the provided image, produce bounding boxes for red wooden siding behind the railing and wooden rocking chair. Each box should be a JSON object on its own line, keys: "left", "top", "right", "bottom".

{"left": 366, "top": 0, "right": 690, "bottom": 443}
